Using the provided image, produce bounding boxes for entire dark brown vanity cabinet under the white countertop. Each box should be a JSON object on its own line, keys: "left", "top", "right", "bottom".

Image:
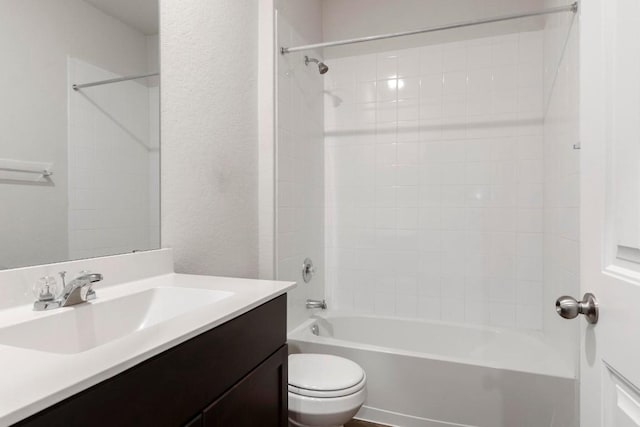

{"left": 17, "top": 295, "right": 288, "bottom": 427}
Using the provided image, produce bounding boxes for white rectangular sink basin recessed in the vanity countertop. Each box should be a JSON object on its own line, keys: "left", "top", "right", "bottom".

{"left": 0, "top": 287, "right": 233, "bottom": 354}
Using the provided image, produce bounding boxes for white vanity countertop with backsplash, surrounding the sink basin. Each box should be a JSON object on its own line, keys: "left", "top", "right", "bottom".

{"left": 0, "top": 249, "right": 295, "bottom": 425}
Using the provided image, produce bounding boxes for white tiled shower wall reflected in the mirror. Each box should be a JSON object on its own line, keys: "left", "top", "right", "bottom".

{"left": 69, "top": 58, "right": 160, "bottom": 259}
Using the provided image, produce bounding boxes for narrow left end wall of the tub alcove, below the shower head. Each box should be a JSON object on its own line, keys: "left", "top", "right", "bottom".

{"left": 276, "top": 0, "right": 325, "bottom": 329}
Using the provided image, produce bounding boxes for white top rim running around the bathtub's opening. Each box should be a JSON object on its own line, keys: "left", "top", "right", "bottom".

{"left": 287, "top": 310, "right": 577, "bottom": 380}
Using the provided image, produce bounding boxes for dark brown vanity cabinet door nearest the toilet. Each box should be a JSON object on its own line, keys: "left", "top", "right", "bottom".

{"left": 203, "top": 345, "right": 288, "bottom": 427}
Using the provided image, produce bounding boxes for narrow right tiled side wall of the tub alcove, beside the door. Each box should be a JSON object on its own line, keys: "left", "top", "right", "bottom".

{"left": 543, "top": 0, "right": 581, "bottom": 369}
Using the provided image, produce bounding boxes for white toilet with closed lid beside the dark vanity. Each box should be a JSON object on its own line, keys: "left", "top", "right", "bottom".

{"left": 289, "top": 354, "right": 367, "bottom": 427}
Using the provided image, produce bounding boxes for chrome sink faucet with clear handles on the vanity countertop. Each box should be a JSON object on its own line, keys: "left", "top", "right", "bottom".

{"left": 33, "top": 271, "right": 102, "bottom": 311}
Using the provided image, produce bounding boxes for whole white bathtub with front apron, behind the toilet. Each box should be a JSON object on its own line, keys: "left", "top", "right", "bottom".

{"left": 289, "top": 312, "right": 577, "bottom": 427}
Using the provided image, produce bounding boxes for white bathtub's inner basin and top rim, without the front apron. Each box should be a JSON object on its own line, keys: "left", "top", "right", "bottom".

{"left": 291, "top": 311, "right": 575, "bottom": 379}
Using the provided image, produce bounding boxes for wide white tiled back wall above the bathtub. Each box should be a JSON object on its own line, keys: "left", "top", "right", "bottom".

{"left": 324, "top": 31, "right": 543, "bottom": 329}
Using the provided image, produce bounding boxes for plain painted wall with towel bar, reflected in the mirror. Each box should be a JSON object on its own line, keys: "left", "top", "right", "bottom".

{"left": 0, "top": 0, "right": 154, "bottom": 268}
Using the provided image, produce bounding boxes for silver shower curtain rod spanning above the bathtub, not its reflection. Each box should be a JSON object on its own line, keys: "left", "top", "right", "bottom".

{"left": 280, "top": 2, "right": 578, "bottom": 55}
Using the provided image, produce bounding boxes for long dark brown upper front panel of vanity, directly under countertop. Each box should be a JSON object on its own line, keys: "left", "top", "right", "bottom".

{"left": 17, "top": 295, "right": 287, "bottom": 427}
